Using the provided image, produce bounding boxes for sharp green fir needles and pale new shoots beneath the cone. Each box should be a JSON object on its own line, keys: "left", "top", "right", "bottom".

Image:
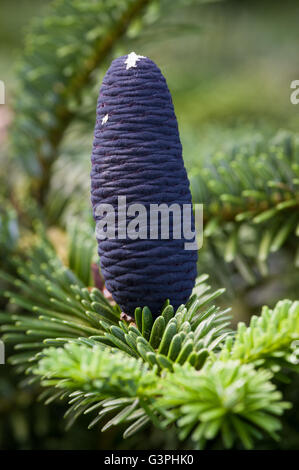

{"left": 1, "top": 237, "right": 299, "bottom": 448}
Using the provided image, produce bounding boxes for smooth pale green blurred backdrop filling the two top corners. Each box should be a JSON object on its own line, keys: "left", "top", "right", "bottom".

{"left": 0, "top": 0, "right": 299, "bottom": 163}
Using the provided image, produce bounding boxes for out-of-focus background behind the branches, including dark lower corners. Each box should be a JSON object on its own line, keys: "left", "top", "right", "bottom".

{"left": 0, "top": 0, "right": 299, "bottom": 449}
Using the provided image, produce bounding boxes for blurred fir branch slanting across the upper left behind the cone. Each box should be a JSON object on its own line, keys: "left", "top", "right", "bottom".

{"left": 13, "top": 0, "right": 155, "bottom": 203}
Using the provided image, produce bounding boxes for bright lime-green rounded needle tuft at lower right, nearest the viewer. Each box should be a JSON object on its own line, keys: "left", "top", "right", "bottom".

{"left": 157, "top": 360, "right": 290, "bottom": 449}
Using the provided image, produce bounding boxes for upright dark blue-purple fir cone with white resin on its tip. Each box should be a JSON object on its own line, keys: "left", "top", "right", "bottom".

{"left": 91, "top": 52, "right": 197, "bottom": 316}
